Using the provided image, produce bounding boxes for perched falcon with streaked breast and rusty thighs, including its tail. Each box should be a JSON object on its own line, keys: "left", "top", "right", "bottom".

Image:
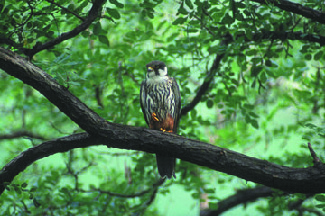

{"left": 140, "top": 61, "right": 181, "bottom": 179}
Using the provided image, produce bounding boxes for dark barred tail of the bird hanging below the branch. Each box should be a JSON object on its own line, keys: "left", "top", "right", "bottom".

{"left": 156, "top": 155, "right": 176, "bottom": 179}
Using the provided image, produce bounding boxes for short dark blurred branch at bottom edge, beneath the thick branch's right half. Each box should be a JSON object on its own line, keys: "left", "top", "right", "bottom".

{"left": 200, "top": 186, "right": 274, "bottom": 216}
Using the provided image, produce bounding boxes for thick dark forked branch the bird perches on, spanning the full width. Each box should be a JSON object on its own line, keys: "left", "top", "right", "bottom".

{"left": 0, "top": 48, "right": 325, "bottom": 196}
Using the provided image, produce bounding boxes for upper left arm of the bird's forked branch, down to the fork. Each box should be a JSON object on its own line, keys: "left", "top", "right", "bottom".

{"left": 0, "top": 48, "right": 108, "bottom": 134}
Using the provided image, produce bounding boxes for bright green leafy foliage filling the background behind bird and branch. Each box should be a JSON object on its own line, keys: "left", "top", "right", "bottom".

{"left": 0, "top": 0, "right": 325, "bottom": 215}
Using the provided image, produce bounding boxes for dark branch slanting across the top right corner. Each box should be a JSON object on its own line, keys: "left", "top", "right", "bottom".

{"left": 253, "top": 0, "right": 325, "bottom": 24}
